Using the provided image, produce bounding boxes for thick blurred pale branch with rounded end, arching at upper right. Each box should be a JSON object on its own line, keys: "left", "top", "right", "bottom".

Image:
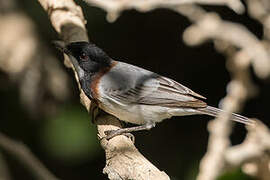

{"left": 184, "top": 13, "right": 270, "bottom": 78}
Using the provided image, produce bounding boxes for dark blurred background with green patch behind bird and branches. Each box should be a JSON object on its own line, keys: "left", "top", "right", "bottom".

{"left": 0, "top": 1, "right": 270, "bottom": 180}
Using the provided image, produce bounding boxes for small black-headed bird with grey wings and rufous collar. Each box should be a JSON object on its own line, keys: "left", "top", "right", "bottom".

{"left": 54, "top": 41, "right": 254, "bottom": 139}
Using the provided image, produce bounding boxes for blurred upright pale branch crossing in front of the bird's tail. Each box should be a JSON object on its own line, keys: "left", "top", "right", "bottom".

{"left": 197, "top": 50, "right": 254, "bottom": 180}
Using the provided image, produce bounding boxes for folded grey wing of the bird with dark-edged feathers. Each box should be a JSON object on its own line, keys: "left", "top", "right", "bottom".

{"left": 99, "top": 63, "right": 206, "bottom": 108}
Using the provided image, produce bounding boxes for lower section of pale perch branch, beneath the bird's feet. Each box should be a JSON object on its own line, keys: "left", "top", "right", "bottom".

{"left": 98, "top": 115, "right": 169, "bottom": 180}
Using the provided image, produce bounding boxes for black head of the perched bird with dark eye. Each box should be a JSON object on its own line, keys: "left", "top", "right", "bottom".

{"left": 64, "top": 41, "right": 112, "bottom": 73}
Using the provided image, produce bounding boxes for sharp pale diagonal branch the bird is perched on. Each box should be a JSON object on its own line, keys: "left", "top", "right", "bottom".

{"left": 39, "top": 0, "right": 169, "bottom": 179}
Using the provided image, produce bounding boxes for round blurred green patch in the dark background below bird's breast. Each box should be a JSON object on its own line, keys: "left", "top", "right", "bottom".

{"left": 40, "top": 107, "right": 101, "bottom": 163}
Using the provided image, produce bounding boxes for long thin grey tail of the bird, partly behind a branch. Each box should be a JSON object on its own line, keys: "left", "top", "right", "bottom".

{"left": 197, "top": 106, "right": 255, "bottom": 125}
